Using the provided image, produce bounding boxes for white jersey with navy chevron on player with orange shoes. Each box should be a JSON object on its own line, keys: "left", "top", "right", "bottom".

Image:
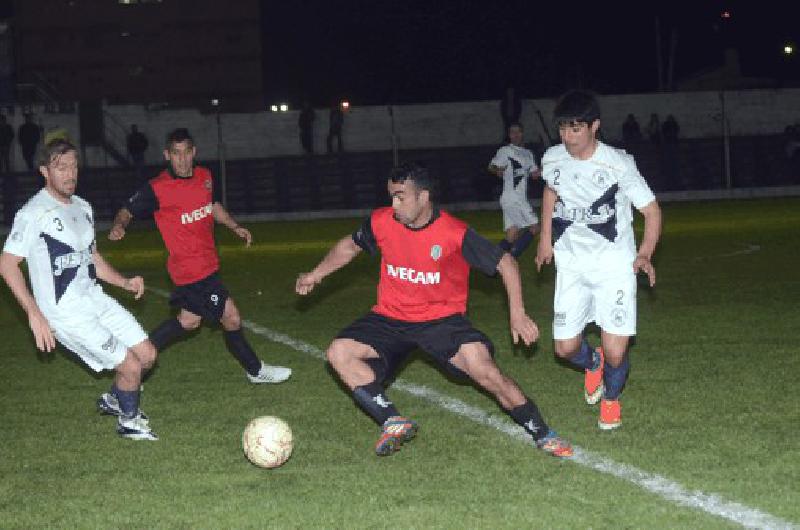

{"left": 542, "top": 141, "right": 655, "bottom": 270}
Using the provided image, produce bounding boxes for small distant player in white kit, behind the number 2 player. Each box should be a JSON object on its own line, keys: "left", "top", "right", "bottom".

{"left": 489, "top": 123, "right": 540, "bottom": 258}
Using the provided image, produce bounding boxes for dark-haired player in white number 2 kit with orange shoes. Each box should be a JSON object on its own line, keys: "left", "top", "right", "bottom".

{"left": 536, "top": 91, "right": 661, "bottom": 430}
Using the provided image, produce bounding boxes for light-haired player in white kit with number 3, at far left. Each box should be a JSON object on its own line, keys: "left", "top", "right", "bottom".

{"left": 0, "top": 139, "right": 158, "bottom": 440}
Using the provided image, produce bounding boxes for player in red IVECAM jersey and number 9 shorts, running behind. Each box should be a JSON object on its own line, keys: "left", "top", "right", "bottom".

{"left": 108, "top": 128, "right": 292, "bottom": 383}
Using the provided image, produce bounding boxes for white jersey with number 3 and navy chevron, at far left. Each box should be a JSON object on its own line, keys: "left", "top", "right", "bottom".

{"left": 3, "top": 188, "right": 101, "bottom": 321}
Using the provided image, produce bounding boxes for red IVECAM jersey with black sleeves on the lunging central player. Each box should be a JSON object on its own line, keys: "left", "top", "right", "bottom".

{"left": 353, "top": 207, "right": 503, "bottom": 322}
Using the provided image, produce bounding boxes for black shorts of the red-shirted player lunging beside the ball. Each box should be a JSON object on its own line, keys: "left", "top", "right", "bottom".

{"left": 336, "top": 313, "right": 494, "bottom": 380}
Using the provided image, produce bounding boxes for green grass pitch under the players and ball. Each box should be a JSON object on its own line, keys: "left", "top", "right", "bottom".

{"left": 0, "top": 199, "right": 800, "bottom": 528}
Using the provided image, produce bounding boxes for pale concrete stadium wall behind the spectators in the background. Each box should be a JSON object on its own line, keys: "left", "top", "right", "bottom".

{"left": 3, "top": 89, "right": 800, "bottom": 170}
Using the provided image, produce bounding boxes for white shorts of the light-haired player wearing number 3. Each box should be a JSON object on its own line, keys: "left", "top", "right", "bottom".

{"left": 48, "top": 290, "right": 147, "bottom": 372}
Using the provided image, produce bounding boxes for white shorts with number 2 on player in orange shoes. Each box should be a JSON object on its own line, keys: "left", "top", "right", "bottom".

{"left": 553, "top": 268, "right": 636, "bottom": 340}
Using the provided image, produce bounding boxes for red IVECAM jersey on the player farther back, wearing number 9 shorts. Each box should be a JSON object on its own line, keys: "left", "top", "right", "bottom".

{"left": 125, "top": 166, "right": 219, "bottom": 285}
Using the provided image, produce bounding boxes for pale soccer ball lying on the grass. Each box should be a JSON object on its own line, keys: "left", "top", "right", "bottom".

{"left": 242, "top": 416, "right": 294, "bottom": 469}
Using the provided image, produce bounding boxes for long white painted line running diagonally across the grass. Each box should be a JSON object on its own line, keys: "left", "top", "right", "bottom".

{"left": 148, "top": 287, "right": 798, "bottom": 529}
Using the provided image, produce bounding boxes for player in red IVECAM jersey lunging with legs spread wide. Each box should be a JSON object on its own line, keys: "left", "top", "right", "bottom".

{"left": 295, "top": 164, "right": 572, "bottom": 457}
